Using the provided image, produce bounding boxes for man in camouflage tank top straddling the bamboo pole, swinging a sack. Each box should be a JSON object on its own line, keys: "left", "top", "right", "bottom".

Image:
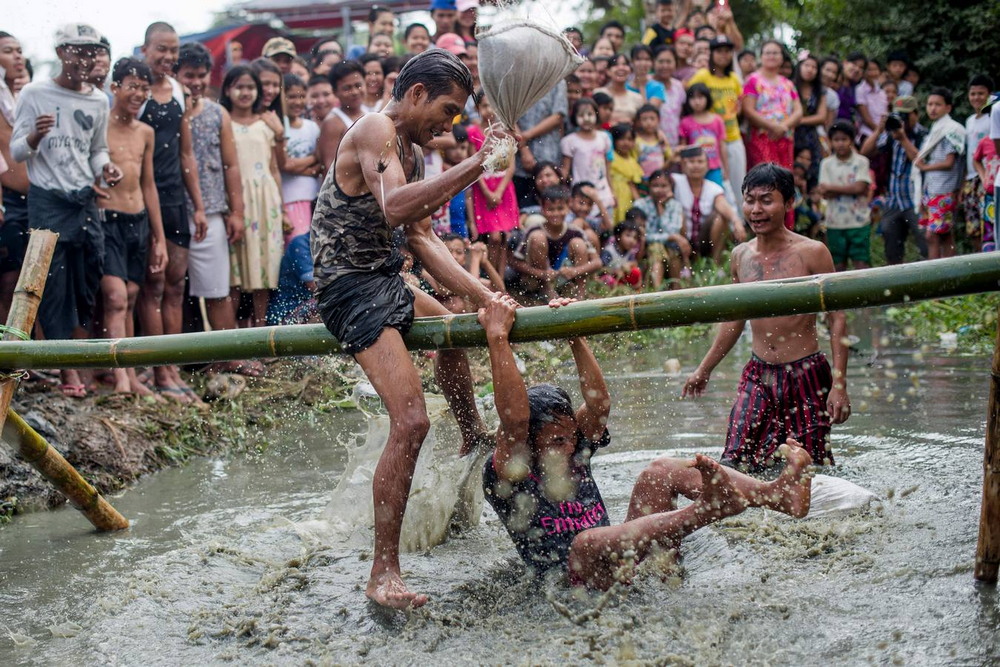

{"left": 312, "top": 49, "right": 510, "bottom": 608}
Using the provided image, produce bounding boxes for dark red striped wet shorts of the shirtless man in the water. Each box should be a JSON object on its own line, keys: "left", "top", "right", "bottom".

{"left": 722, "top": 352, "right": 833, "bottom": 473}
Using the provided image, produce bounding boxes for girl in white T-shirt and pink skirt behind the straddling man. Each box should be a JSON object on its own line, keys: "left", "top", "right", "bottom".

{"left": 281, "top": 74, "right": 322, "bottom": 246}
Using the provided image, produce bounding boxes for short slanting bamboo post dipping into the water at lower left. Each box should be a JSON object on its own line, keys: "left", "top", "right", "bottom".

{"left": 3, "top": 410, "right": 128, "bottom": 531}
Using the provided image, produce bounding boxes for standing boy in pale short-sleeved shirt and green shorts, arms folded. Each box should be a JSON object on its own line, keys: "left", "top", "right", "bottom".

{"left": 816, "top": 120, "right": 871, "bottom": 271}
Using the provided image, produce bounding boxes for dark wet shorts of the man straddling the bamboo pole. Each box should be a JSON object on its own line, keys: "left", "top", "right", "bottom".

{"left": 316, "top": 262, "right": 413, "bottom": 355}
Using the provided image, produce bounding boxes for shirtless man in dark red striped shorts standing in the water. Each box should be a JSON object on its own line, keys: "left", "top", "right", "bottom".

{"left": 682, "top": 163, "right": 851, "bottom": 473}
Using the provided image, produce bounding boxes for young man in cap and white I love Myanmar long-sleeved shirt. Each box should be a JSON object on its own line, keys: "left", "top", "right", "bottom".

{"left": 10, "top": 23, "right": 122, "bottom": 398}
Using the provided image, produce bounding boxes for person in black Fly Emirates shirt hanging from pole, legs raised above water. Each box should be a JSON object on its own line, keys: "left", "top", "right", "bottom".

{"left": 479, "top": 294, "right": 812, "bottom": 589}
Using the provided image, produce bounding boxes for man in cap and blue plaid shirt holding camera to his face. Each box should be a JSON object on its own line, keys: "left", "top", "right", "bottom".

{"left": 860, "top": 95, "right": 927, "bottom": 264}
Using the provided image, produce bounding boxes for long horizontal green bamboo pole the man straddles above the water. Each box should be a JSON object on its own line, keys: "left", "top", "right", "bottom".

{"left": 0, "top": 253, "right": 1000, "bottom": 368}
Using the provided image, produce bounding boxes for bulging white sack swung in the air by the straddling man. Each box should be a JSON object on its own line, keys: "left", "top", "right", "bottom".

{"left": 476, "top": 19, "right": 583, "bottom": 171}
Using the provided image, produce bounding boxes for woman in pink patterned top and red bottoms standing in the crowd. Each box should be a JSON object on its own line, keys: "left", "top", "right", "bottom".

{"left": 743, "top": 40, "right": 802, "bottom": 169}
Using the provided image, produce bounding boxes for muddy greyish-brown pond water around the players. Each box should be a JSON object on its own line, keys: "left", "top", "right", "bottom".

{"left": 0, "top": 320, "right": 1000, "bottom": 665}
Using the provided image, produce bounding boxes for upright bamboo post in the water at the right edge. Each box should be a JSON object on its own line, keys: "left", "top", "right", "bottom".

{"left": 974, "top": 312, "right": 1000, "bottom": 584}
